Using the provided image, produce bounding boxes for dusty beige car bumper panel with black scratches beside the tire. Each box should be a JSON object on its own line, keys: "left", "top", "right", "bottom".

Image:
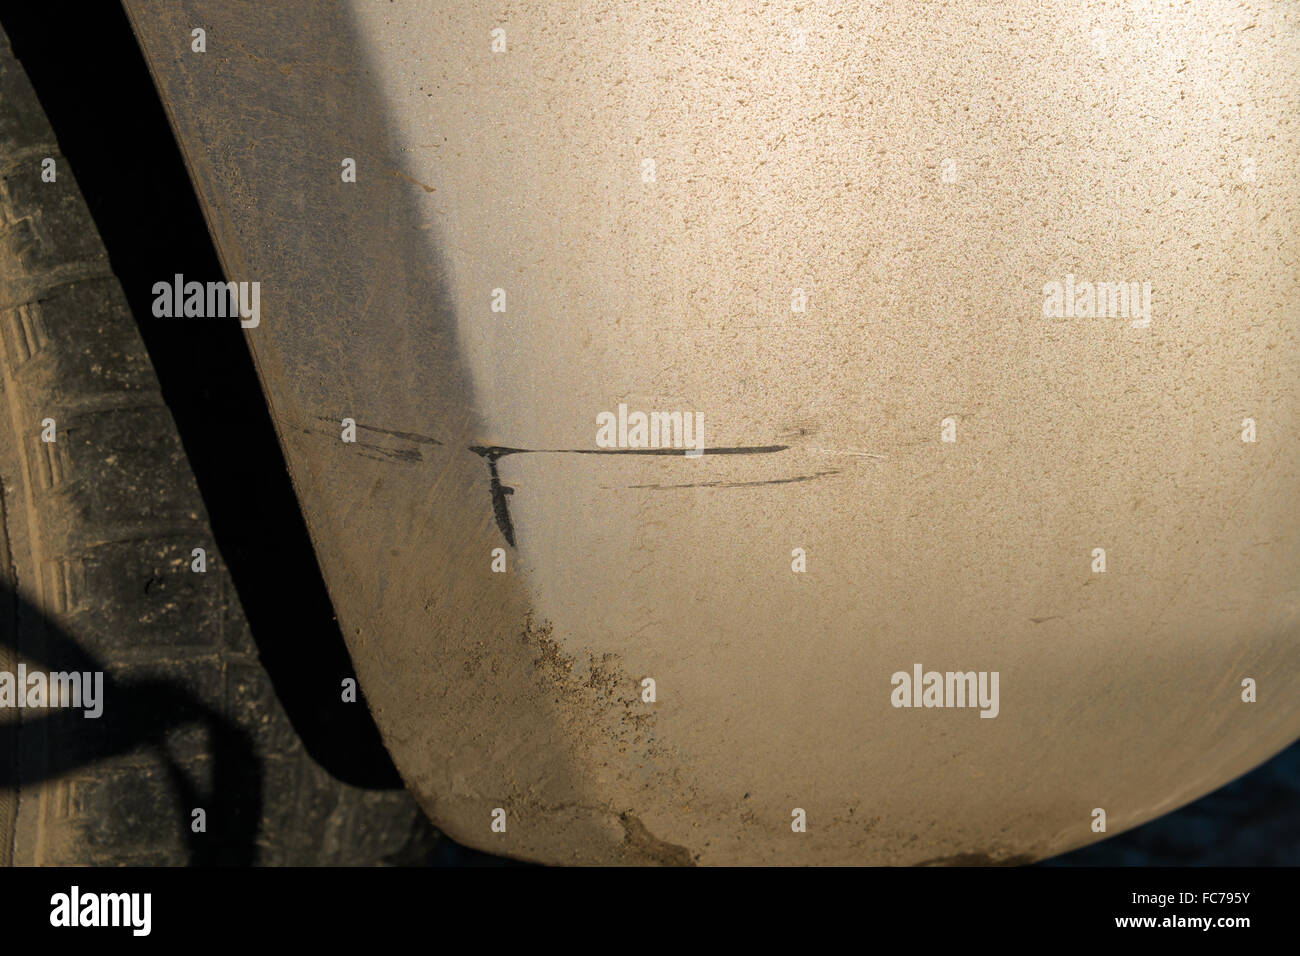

{"left": 127, "top": 0, "right": 1300, "bottom": 864}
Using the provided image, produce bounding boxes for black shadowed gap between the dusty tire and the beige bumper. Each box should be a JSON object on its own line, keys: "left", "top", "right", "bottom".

{"left": 0, "top": 0, "right": 402, "bottom": 788}
